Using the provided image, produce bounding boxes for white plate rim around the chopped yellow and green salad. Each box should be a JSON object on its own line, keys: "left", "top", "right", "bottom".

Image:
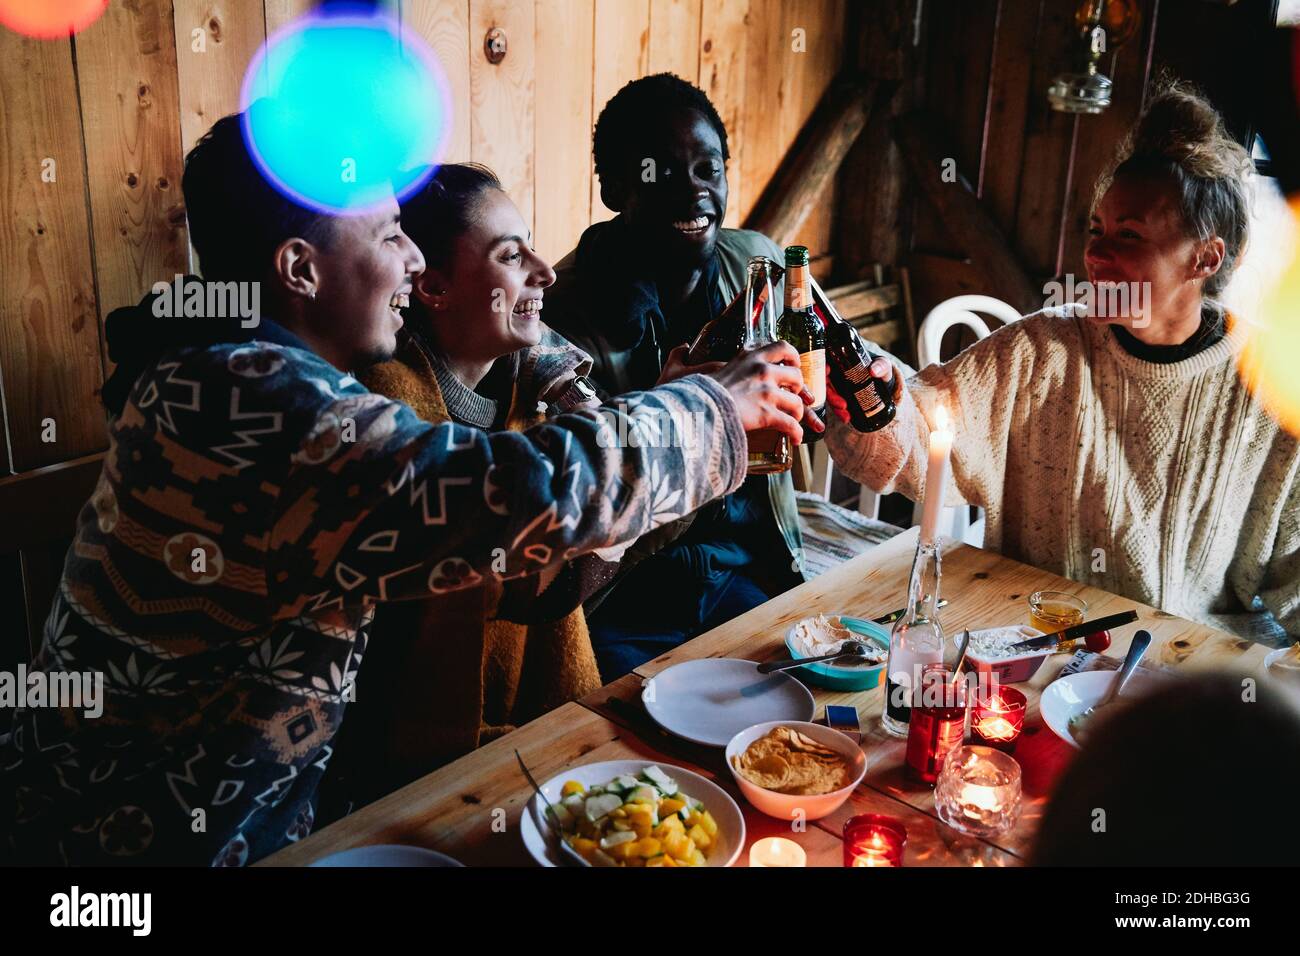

{"left": 519, "top": 760, "right": 745, "bottom": 866}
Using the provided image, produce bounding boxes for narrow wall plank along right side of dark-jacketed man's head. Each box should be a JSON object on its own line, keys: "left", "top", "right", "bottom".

{"left": 699, "top": 0, "right": 749, "bottom": 228}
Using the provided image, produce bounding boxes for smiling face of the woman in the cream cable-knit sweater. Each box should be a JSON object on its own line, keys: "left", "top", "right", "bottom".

{"left": 1084, "top": 176, "right": 1204, "bottom": 329}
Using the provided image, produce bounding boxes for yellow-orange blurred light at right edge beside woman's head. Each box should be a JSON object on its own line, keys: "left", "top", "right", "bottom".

{"left": 1242, "top": 195, "right": 1300, "bottom": 436}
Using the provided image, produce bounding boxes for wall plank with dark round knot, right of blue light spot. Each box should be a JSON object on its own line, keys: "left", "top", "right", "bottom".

{"left": 469, "top": 0, "right": 537, "bottom": 229}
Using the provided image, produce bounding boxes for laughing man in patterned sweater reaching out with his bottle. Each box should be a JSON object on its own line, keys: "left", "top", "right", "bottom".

{"left": 0, "top": 117, "right": 810, "bottom": 864}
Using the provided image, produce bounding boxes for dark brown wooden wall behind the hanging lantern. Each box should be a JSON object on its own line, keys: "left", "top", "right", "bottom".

{"left": 840, "top": 0, "right": 1170, "bottom": 335}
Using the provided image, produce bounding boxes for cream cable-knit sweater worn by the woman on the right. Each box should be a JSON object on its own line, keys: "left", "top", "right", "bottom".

{"left": 827, "top": 310, "right": 1300, "bottom": 637}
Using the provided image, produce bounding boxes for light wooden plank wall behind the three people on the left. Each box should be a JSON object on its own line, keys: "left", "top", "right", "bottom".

{"left": 0, "top": 0, "right": 846, "bottom": 475}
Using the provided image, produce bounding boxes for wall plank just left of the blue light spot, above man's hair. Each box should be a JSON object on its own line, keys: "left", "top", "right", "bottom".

{"left": 173, "top": 0, "right": 267, "bottom": 152}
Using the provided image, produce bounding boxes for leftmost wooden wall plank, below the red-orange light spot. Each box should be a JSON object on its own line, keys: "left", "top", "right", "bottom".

{"left": 0, "top": 30, "right": 105, "bottom": 472}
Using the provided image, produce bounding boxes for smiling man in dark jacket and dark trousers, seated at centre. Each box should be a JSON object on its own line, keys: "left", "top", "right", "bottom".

{"left": 546, "top": 73, "right": 805, "bottom": 680}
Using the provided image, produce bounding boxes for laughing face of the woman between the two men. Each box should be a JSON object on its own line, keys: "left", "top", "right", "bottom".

{"left": 417, "top": 189, "right": 555, "bottom": 362}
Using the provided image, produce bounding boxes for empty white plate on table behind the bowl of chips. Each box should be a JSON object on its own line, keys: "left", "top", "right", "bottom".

{"left": 641, "top": 657, "right": 816, "bottom": 747}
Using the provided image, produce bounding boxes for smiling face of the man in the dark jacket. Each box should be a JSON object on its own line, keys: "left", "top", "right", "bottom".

{"left": 620, "top": 109, "right": 727, "bottom": 267}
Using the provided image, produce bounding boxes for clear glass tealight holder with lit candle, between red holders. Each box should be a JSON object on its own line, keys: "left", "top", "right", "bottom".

{"left": 935, "top": 745, "right": 1021, "bottom": 836}
